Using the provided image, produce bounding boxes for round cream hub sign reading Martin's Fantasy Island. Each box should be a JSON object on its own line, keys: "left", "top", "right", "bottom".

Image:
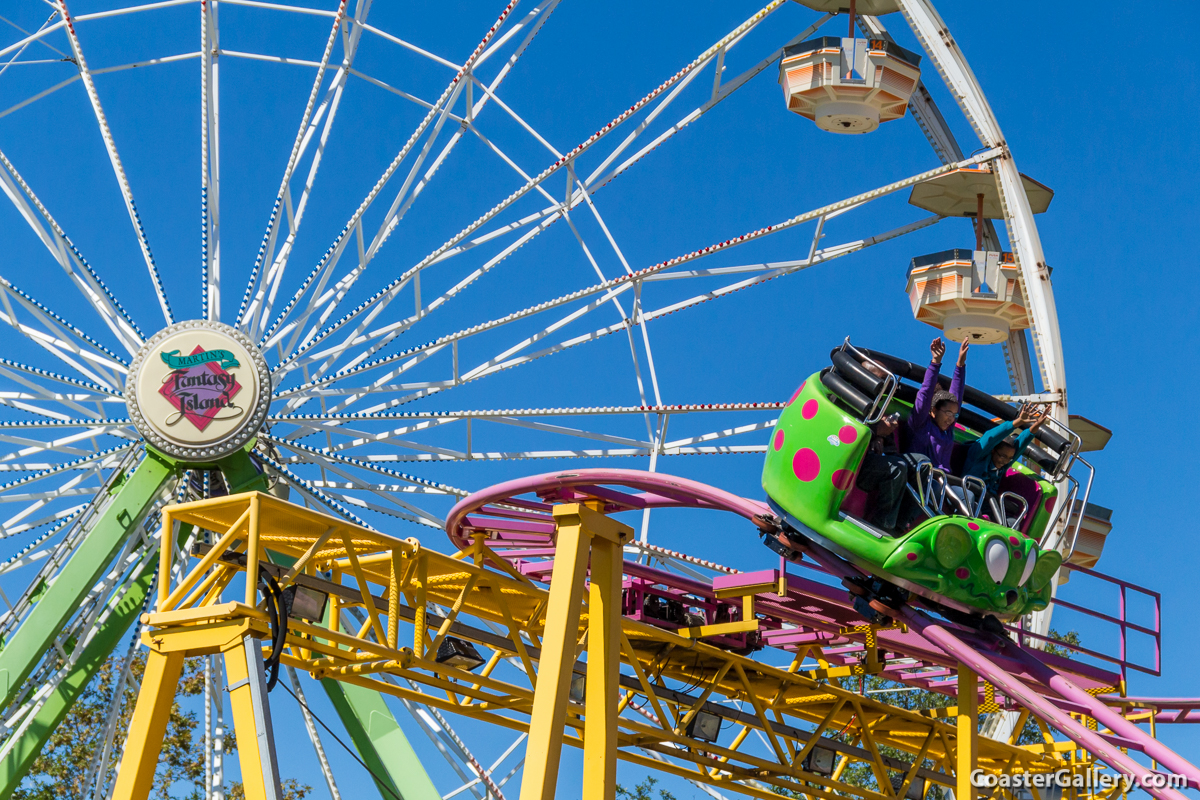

{"left": 125, "top": 320, "right": 270, "bottom": 462}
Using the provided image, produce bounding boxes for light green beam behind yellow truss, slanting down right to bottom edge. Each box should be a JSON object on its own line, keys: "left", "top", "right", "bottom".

{"left": 320, "top": 678, "right": 442, "bottom": 800}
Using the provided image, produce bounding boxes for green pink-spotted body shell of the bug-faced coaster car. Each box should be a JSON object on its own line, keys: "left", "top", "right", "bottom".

{"left": 762, "top": 352, "right": 1062, "bottom": 620}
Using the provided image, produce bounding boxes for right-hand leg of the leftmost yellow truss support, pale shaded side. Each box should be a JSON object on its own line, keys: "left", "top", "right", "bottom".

{"left": 221, "top": 636, "right": 283, "bottom": 800}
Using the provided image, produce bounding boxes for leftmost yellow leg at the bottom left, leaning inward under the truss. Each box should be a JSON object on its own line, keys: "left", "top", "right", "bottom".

{"left": 113, "top": 650, "right": 184, "bottom": 800}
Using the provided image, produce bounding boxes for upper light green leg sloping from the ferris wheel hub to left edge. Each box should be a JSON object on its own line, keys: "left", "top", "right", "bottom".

{"left": 0, "top": 450, "right": 176, "bottom": 708}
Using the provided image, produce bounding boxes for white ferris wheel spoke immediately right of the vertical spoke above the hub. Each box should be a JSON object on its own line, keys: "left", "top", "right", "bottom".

{"left": 236, "top": 0, "right": 371, "bottom": 337}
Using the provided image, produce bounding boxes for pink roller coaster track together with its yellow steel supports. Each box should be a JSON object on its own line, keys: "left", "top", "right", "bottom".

{"left": 114, "top": 470, "right": 1200, "bottom": 800}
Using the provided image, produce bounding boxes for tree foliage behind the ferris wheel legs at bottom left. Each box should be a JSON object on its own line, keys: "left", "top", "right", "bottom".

{"left": 12, "top": 649, "right": 312, "bottom": 800}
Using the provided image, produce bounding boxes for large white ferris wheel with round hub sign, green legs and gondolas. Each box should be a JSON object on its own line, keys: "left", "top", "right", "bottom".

{"left": 0, "top": 0, "right": 1067, "bottom": 798}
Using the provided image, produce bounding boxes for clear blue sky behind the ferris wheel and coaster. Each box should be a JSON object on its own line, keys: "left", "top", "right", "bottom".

{"left": 0, "top": 0, "right": 1200, "bottom": 796}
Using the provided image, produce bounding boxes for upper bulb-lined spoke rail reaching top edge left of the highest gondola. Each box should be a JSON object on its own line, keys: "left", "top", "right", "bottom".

{"left": 264, "top": 0, "right": 782, "bottom": 376}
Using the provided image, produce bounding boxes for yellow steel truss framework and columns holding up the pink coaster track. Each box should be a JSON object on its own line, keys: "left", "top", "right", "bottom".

{"left": 116, "top": 493, "right": 1113, "bottom": 800}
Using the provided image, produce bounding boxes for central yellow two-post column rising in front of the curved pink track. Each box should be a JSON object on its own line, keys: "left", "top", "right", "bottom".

{"left": 521, "top": 504, "right": 634, "bottom": 800}
